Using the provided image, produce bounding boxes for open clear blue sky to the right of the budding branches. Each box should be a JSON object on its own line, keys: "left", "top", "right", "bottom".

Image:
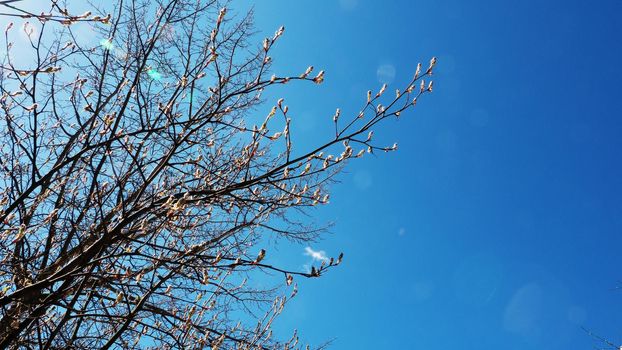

{"left": 241, "top": 0, "right": 622, "bottom": 350}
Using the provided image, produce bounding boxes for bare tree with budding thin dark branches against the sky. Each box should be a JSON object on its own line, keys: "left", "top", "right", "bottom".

{"left": 0, "top": 0, "right": 436, "bottom": 349}
